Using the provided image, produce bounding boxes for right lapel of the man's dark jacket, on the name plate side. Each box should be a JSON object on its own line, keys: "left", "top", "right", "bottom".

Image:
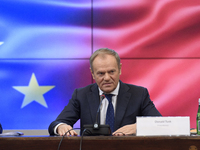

{"left": 115, "top": 81, "right": 131, "bottom": 129}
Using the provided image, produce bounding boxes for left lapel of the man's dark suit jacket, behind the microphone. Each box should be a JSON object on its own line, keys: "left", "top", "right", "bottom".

{"left": 87, "top": 84, "right": 100, "bottom": 123}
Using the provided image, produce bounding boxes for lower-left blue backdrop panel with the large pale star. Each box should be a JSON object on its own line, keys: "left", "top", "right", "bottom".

{"left": 0, "top": 60, "right": 92, "bottom": 129}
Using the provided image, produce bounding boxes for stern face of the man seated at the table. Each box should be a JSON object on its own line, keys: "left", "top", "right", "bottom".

{"left": 90, "top": 54, "right": 121, "bottom": 93}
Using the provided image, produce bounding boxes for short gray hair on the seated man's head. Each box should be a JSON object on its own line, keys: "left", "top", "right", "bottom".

{"left": 90, "top": 48, "right": 120, "bottom": 72}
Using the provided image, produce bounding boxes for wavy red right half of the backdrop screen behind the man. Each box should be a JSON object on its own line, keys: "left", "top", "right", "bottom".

{"left": 93, "top": 0, "right": 200, "bottom": 128}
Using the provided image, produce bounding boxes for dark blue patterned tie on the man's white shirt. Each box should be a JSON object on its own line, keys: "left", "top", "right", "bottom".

{"left": 105, "top": 94, "right": 115, "bottom": 133}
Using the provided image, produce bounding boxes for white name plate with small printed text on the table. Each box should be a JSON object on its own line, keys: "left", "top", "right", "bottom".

{"left": 136, "top": 117, "right": 190, "bottom": 136}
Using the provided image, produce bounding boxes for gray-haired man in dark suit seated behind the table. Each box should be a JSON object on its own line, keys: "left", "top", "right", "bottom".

{"left": 49, "top": 48, "right": 161, "bottom": 136}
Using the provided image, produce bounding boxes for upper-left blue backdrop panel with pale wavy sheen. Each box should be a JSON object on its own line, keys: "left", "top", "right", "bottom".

{"left": 0, "top": 0, "right": 91, "bottom": 58}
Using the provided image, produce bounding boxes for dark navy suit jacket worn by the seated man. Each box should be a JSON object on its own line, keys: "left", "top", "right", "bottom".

{"left": 49, "top": 81, "right": 161, "bottom": 135}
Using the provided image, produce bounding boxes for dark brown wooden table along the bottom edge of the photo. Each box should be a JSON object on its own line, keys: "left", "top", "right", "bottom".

{"left": 0, "top": 136, "right": 200, "bottom": 150}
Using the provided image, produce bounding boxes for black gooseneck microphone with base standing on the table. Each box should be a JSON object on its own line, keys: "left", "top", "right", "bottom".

{"left": 83, "top": 93, "right": 111, "bottom": 136}
